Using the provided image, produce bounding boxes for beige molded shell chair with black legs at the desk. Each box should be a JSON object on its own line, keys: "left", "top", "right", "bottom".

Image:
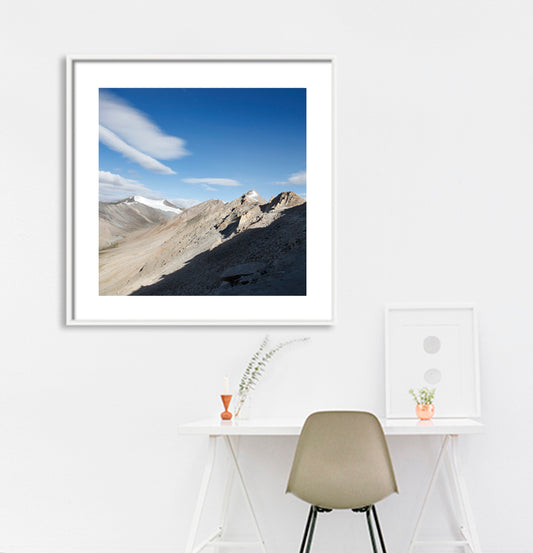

{"left": 287, "top": 411, "right": 398, "bottom": 553}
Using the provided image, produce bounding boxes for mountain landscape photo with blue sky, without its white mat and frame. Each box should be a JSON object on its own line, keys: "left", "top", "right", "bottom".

{"left": 98, "top": 89, "right": 307, "bottom": 296}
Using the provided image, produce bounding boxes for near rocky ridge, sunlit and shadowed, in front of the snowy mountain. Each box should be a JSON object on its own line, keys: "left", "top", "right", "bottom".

{"left": 100, "top": 190, "right": 306, "bottom": 295}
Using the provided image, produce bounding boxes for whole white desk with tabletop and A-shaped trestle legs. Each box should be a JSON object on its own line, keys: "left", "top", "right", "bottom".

{"left": 179, "top": 418, "right": 484, "bottom": 553}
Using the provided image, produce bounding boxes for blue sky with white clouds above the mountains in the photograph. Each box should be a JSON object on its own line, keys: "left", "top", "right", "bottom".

{"left": 99, "top": 88, "right": 306, "bottom": 205}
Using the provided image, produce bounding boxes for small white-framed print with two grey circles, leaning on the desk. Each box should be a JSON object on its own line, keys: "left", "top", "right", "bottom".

{"left": 385, "top": 304, "right": 480, "bottom": 418}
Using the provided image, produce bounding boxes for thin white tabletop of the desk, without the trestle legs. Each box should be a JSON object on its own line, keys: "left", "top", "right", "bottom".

{"left": 178, "top": 417, "right": 485, "bottom": 436}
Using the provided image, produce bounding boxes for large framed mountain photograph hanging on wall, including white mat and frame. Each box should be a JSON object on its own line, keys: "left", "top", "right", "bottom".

{"left": 67, "top": 56, "right": 333, "bottom": 325}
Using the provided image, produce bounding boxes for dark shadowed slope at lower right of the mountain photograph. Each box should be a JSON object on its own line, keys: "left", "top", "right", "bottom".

{"left": 130, "top": 204, "right": 306, "bottom": 296}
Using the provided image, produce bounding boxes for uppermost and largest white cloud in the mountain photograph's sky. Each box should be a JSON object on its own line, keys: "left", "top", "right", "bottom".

{"left": 99, "top": 92, "right": 189, "bottom": 159}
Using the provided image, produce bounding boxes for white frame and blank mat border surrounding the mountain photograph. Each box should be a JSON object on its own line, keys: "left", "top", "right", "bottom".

{"left": 66, "top": 56, "right": 334, "bottom": 325}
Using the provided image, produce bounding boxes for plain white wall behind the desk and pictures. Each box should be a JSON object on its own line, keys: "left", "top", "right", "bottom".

{"left": 0, "top": 0, "right": 533, "bottom": 553}
